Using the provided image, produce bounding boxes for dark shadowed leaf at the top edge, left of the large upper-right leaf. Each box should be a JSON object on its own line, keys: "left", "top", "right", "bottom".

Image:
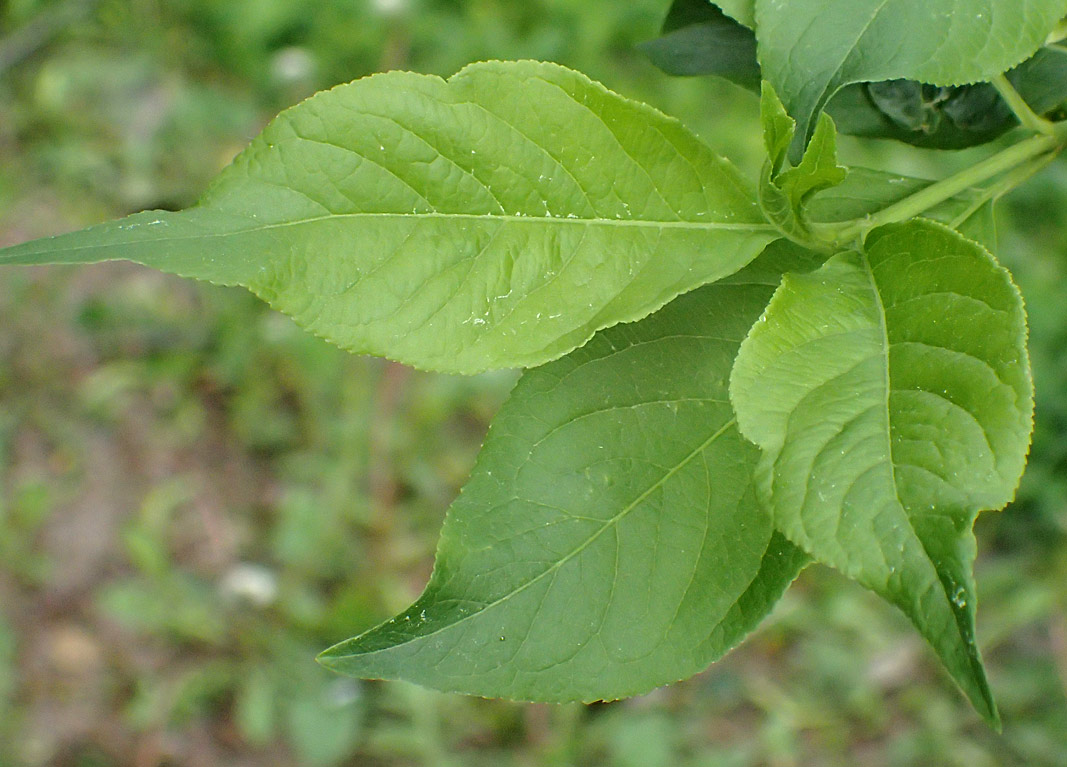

{"left": 638, "top": 0, "right": 760, "bottom": 91}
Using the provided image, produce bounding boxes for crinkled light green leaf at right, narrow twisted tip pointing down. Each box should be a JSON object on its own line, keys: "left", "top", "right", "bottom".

{"left": 730, "top": 221, "right": 1033, "bottom": 721}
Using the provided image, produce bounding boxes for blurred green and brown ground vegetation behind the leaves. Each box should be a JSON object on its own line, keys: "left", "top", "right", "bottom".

{"left": 0, "top": 0, "right": 1067, "bottom": 767}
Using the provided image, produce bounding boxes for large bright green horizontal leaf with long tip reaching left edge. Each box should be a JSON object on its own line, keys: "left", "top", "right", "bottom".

{"left": 0, "top": 62, "right": 777, "bottom": 372}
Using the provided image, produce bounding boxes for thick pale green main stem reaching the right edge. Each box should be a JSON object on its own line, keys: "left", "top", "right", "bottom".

{"left": 811, "top": 131, "right": 1067, "bottom": 245}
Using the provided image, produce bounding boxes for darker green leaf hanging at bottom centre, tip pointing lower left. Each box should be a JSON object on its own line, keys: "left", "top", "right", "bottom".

{"left": 320, "top": 243, "right": 814, "bottom": 702}
